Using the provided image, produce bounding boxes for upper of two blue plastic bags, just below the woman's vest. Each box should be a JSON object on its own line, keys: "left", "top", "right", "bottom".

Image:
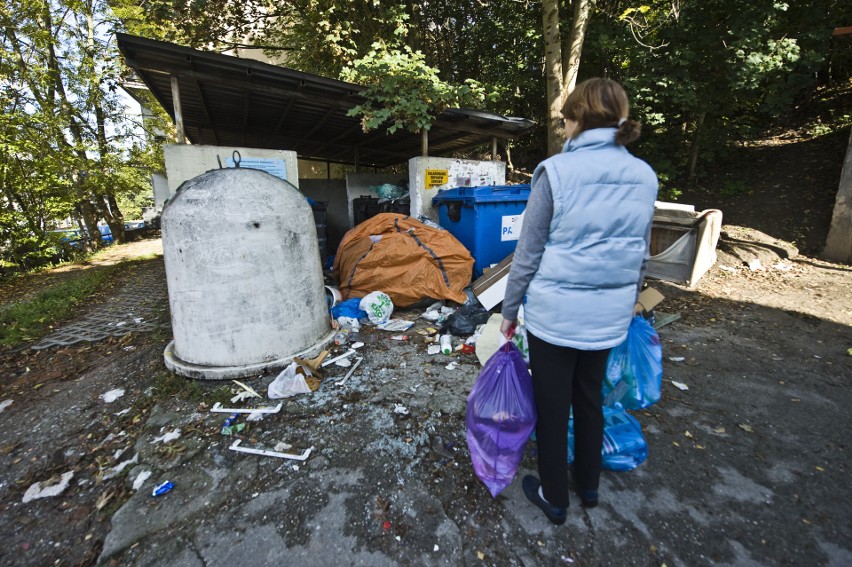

{"left": 603, "top": 315, "right": 663, "bottom": 409}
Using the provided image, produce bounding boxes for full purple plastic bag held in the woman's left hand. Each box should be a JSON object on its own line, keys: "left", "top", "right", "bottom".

{"left": 466, "top": 342, "right": 536, "bottom": 498}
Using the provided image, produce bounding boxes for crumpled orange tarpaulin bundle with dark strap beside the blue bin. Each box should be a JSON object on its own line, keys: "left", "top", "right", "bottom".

{"left": 334, "top": 213, "right": 480, "bottom": 307}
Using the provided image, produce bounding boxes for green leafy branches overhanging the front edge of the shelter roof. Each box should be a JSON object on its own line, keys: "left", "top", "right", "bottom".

{"left": 342, "top": 42, "right": 496, "bottom": 134}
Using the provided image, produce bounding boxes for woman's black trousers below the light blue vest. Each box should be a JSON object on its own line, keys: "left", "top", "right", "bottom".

{"left": 528, "top": 333, "right": 609, "bottom": 507}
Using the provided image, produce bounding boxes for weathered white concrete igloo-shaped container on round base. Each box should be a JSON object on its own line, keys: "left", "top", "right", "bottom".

{"left": 161, "top": 168, "right": 332, "bottom": 379}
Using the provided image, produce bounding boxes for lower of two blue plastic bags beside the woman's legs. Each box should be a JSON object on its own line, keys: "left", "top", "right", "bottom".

{"left": 568, "top": 407, "right": 648, "bottom": 471}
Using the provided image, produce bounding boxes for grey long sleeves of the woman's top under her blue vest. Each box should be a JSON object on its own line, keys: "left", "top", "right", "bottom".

{"left": 502, "top": 172, "right": 651, "bottom": 320}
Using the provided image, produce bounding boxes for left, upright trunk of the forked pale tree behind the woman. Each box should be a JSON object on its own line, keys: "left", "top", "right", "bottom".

{"left": 542, "top": 0, "right": 565, "bottom": 156}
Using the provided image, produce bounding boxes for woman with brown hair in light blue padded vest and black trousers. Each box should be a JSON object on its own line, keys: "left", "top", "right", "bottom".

{"left": 500, "top": 79, "right": 657, "bottom": 524}
